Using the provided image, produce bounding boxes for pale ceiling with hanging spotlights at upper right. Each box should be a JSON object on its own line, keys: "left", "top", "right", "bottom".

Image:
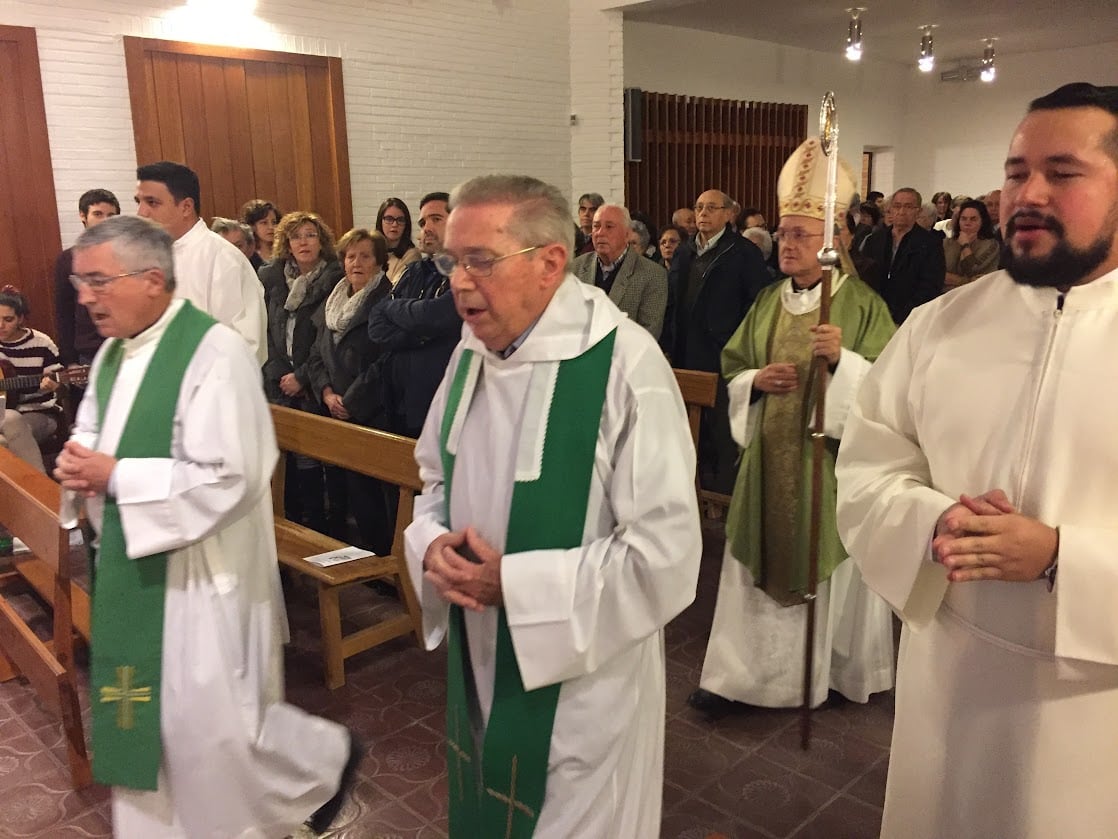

{"left": 625, "top": 0, "right": 1118, "bottom": 67}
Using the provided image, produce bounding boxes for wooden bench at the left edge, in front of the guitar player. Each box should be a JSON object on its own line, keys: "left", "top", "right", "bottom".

{"left": 0, "top": 449, "right": 93, "bottom": 789}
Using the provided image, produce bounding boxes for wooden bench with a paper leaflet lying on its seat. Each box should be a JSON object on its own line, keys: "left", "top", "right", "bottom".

{"left": 272, "top": 405, "right": 423, "bottom": 689}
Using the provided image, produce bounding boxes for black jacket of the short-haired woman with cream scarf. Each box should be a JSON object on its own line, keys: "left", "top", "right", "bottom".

{"left": 306, "top": 276, "right": 390, "bottom": 427}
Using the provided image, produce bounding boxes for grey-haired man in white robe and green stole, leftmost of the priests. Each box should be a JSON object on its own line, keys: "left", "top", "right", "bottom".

{"left": 55, "top": 216, "right": 359, "bottom": 839}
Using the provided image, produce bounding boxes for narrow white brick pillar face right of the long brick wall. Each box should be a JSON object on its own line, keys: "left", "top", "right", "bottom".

{"left": 570, "top": 0, "right": 625, "bottom": 204}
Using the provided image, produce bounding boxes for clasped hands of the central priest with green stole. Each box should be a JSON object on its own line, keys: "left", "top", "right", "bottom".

{"left": 423, "top": 527, "right": 501, "bottom": 612}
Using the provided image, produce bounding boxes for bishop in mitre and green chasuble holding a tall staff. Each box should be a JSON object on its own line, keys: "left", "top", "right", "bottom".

{"left": 688, "top": 138, "right": 893, "bottom": 714}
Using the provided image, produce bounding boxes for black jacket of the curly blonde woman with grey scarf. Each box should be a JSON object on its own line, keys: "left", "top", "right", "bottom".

{"left": 259, "top": 262, "right": 345, "bottom": 407}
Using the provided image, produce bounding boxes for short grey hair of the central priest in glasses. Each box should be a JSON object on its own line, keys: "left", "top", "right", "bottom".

{"left": 449, "top": 175, "right": 575, "bottom": 260}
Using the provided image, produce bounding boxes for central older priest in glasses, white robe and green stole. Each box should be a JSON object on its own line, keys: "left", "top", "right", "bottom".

{"left": 406, "top": 176, "right": 701, "bottom": 839}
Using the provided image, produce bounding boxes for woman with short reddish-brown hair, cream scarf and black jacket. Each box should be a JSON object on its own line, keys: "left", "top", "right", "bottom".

{"left": 307, "top": 228, "right": 394, "bottom": 556}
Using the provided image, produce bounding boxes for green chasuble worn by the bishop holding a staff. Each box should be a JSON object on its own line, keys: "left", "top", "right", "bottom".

{"left": 722, "top": 276, "right": 896, "bottom": 605}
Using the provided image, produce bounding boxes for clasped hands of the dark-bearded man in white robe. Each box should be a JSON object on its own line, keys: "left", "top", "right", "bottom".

{"left": 931, "top": 489, "right": 1059, "bottom": 583}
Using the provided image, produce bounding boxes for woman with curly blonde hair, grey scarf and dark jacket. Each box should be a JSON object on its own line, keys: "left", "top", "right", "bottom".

{"left": 260, "top": 210, "right": 345, "bottom": 532}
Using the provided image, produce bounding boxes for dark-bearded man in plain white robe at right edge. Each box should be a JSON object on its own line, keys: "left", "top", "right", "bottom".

{"left": 837, "top": 83, "right": 1118, "bottom": 839}
